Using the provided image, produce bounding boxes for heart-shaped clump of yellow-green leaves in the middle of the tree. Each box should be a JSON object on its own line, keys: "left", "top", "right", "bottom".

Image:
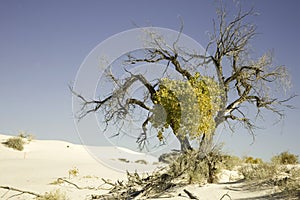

{"left": 150, "top": 73, "right": 223, "bottom": 140}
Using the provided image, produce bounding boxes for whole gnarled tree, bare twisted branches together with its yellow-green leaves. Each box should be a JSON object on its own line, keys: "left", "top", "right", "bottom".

{"left": 72, "top": 5, "right": 293, "bottom": 151}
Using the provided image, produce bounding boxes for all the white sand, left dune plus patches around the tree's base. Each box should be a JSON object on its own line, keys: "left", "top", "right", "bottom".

{"left": 0, "top": 135, "right": 276, "bottom": 200}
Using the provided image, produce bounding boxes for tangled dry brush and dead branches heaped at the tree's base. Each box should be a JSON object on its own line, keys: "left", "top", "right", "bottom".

{"left": 97, "top": 149, "right": 226, "bottom": 199}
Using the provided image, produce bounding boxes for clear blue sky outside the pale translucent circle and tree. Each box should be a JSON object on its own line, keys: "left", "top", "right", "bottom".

{"left": 0, "top": 0, "right": 300, "bottom": 159}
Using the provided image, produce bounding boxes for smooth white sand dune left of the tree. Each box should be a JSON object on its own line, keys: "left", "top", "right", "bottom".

{"left": 0, "top": 135, "right": 125, "bottom": 199}
